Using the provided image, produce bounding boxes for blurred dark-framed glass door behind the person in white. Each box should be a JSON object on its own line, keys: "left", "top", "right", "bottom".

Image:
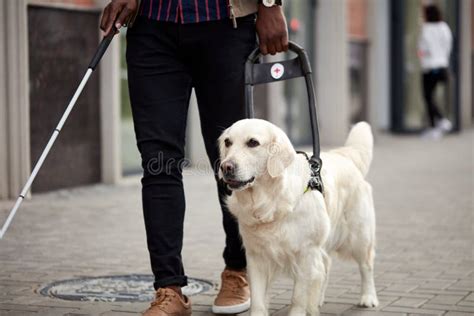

{"left": 391, "top": 0, "right": 460, "bottom": 133}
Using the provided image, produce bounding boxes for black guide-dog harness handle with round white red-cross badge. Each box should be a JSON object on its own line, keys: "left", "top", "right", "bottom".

{"left": 245, "top": 41, "right": 323, "bottom": 192}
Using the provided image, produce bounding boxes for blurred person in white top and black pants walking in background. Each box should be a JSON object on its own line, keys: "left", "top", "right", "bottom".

{"left": 418, "top": 4, "right": 453, "bottom": 139}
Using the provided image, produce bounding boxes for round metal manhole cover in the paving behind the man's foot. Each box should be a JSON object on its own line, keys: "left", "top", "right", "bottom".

{"left": 40, "top": 274, "right": 213, "bottom": 302}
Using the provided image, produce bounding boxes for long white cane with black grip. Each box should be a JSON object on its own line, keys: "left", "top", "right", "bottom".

{"left": 0, "top": 28, "right": 116, "bottom": 239}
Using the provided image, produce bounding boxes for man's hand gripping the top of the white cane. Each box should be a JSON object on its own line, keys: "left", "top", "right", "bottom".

{"left": 100, "top": 0, "right": 138, "bottom": 36}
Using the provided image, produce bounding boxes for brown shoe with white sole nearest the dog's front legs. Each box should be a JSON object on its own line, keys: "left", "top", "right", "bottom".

{"left": 212, "top": 268, "right": 250, "bottom": 314}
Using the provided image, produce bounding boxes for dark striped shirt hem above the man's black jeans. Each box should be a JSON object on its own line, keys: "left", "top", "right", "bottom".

{"left": 139, "top": 0, "right": 230, "bottom": 24}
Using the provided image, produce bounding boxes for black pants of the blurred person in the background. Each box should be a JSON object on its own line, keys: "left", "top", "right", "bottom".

{"left": 422, "top": 68, "right": 448, "bottom": 127}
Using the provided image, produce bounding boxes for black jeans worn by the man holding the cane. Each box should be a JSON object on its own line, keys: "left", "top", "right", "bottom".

{"left": 127, "top": 16, "right": 256, "bottom": 288}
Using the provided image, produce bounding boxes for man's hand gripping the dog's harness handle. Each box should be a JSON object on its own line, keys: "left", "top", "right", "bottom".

{"left": 256, "top": 4, "right": 288, "bottom": 55}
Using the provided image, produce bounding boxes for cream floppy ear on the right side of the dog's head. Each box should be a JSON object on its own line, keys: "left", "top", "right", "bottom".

{"left": 267, "top": 131, "right": 296, "bottom": 178}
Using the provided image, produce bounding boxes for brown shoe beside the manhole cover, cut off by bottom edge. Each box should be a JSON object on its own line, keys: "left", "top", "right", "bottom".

{"left": 142, "top": 288, "right": 191, "bottom": 316}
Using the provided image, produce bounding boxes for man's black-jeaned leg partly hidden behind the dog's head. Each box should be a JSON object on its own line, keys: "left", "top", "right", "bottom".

{"left": 183, "top": 16, "right": 256, "bottom": 270}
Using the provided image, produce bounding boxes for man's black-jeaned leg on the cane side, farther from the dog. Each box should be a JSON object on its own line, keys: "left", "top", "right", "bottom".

{"left": 127, "top": 18, "right": 191, "bottom": 289}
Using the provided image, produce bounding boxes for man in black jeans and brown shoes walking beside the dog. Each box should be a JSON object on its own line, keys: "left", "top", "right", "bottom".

{"left": 101, "top": 0, "right": 288, "bottom": 316}
